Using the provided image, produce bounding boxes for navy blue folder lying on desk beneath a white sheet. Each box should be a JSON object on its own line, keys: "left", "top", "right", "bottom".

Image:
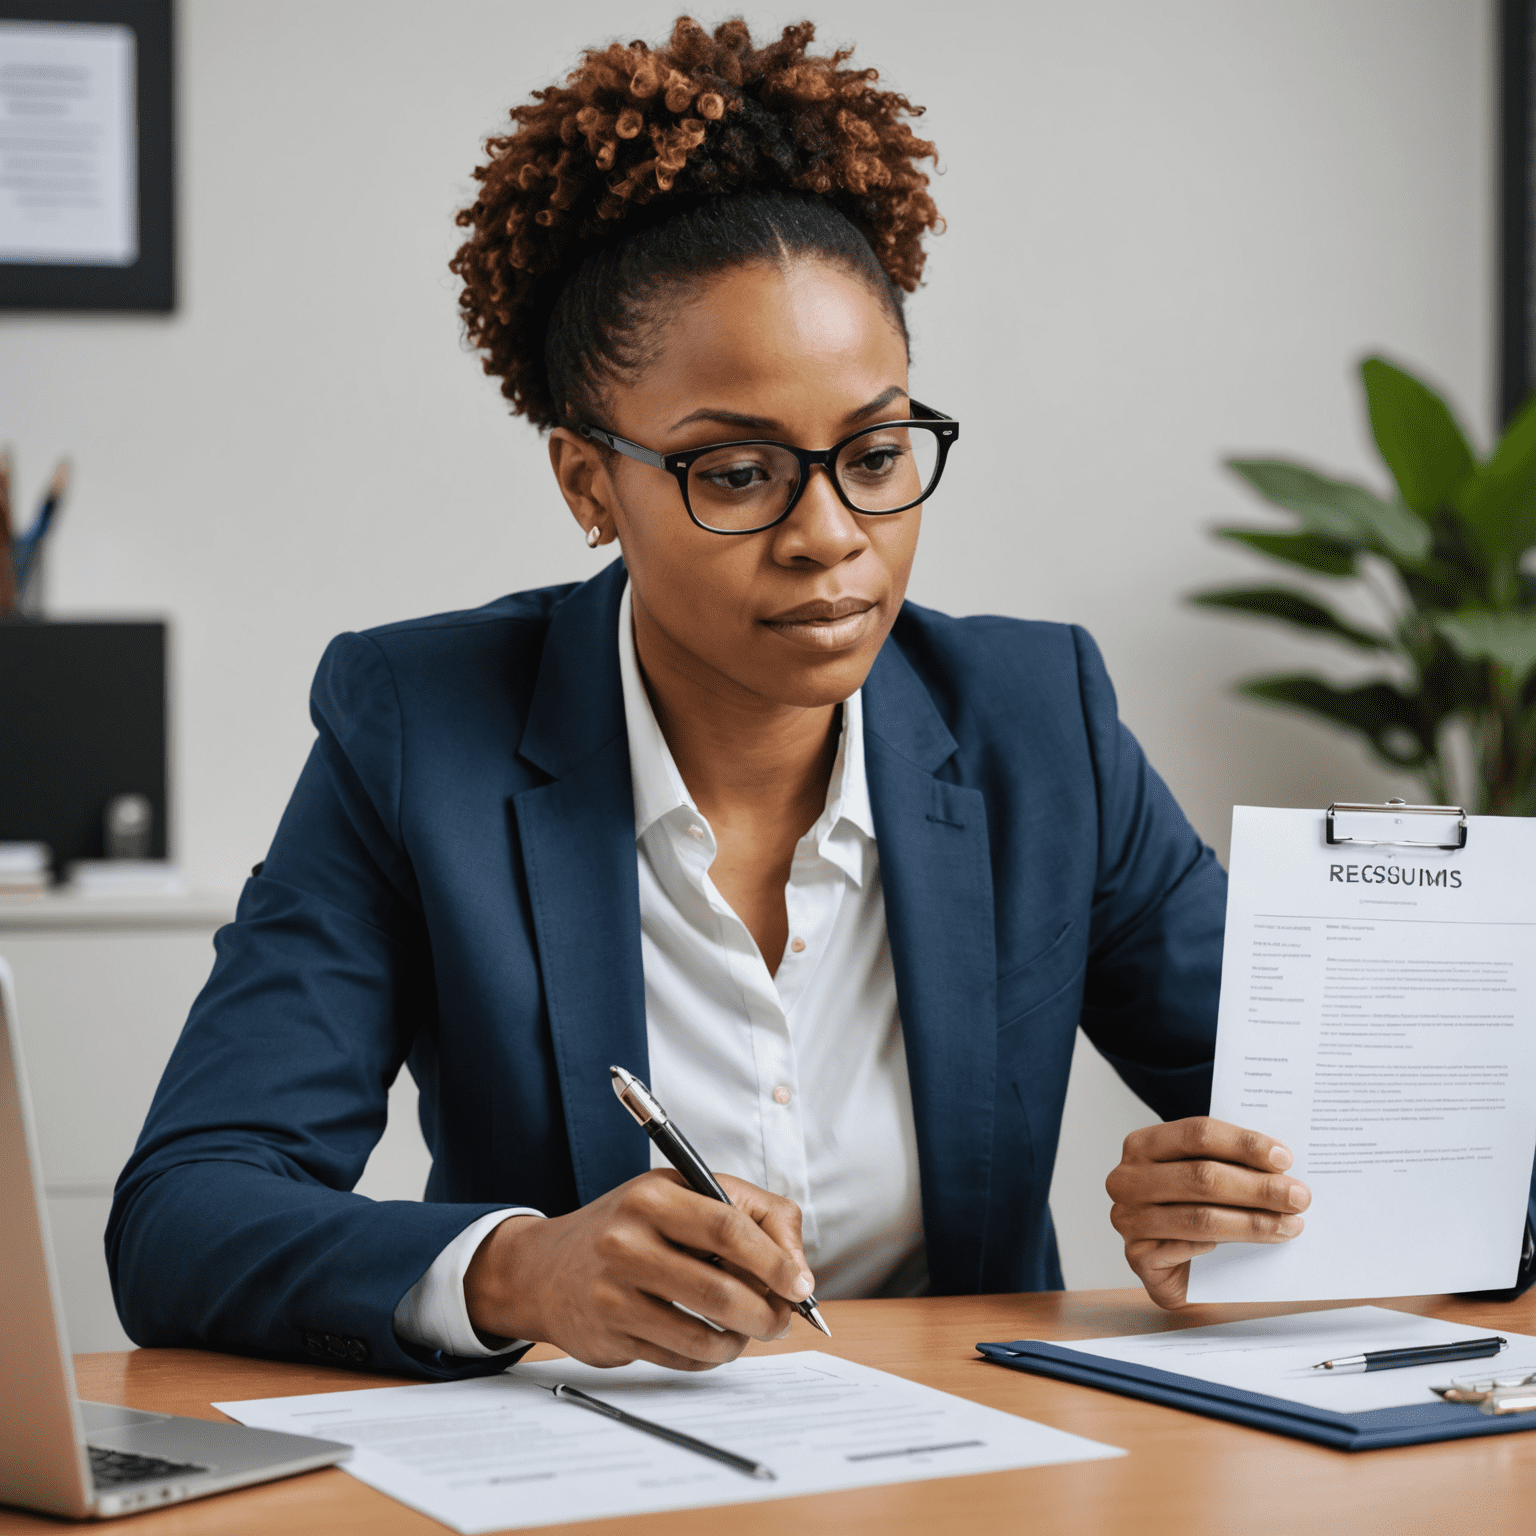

{"left": 977, "top": 1339, "right": 1536, "bottom": 1450}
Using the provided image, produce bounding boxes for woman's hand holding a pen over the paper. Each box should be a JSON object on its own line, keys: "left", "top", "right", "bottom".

{"left": 464, "top": 1169, "right": 814, "bottom": 1370}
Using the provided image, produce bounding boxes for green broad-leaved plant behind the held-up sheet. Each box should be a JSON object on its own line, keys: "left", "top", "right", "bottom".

{"left": 1190, "top": 358, "right": 1536, "bottom": 816}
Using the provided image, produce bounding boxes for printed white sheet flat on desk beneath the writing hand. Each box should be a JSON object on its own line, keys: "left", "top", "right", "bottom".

{"left": 214, "top": 1350, "right": 1124, "bottom": 1536}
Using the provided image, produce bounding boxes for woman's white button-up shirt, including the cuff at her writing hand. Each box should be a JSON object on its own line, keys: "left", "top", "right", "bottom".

{"left": 395, "top": 588, "right": 923, "bottom": 1356}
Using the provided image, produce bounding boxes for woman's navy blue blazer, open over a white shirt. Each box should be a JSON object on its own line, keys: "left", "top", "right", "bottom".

{"left": 108, "top": 562, "right": 1226, "bottom": 1376}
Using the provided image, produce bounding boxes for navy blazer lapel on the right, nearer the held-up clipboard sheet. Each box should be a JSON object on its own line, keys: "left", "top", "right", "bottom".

{"left": 863, "top": 641, "right": 997, "bottom": 1293}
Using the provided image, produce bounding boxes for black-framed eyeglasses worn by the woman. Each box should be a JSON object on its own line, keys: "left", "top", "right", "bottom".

{"left": 579, "top": 399, "right": 960, "bottom": 533}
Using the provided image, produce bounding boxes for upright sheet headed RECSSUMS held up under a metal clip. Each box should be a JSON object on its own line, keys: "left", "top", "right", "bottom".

{"left": 1189, "top": 805, "right": 1536, "bottom": 1301}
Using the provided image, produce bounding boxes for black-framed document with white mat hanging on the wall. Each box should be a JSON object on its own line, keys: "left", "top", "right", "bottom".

{"left": 0, "top": 0, "right": 175, "bottom": 312}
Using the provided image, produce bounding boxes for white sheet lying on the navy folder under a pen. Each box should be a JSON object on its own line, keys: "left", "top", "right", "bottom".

{"left": 1061, "top": 1307, "right": 1536, "bottom": 1413}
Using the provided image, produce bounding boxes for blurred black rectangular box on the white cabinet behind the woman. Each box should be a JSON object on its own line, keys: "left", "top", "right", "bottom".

{"left": 0, "top": 619, "right": 170, "bottom": 877}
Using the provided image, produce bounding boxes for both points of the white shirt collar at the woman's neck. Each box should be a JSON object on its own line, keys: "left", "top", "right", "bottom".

{"left": 619, "top": 582, "right": 874, "bottom": 866}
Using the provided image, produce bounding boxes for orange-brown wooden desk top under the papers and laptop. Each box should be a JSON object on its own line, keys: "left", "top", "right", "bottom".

{"left": 0, "top": 1290, "right": 1536, "bottom": 1536}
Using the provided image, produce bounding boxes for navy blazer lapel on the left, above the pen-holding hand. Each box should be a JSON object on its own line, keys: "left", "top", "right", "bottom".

{"left": 513, "top": 561, "right": 650, "bottom": 1204}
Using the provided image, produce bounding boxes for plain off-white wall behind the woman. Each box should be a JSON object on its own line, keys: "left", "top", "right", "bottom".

{"left": 0, "top": 0, "right": 1491, "bottom": 1284}
